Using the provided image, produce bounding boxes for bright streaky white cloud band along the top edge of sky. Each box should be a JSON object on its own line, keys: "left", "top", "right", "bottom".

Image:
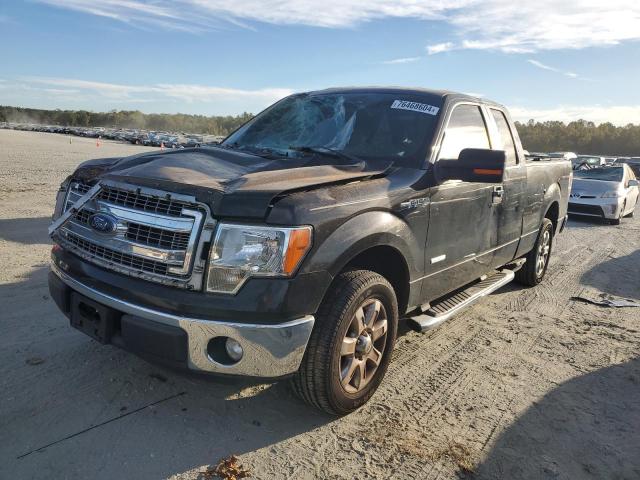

{"left": 38, "top": 0, "right": 640, "bottom": 53}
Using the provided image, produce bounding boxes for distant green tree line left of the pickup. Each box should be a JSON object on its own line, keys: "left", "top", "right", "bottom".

{"left": 0, "top": 106, "right": 253, "bottom": 135}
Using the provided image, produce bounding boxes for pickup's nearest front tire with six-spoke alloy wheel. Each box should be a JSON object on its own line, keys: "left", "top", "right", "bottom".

{"left": 292, "top": 270, "right": 398, "bottom": 415}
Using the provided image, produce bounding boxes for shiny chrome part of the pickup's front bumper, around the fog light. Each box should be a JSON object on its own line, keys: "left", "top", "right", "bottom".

{"left": 51, "top": 263, "right": 314, "bottom": 377}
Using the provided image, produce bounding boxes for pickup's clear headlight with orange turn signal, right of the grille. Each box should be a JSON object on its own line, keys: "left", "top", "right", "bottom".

{"left": 207, "top": 223, "right": 312, "bottom": 293}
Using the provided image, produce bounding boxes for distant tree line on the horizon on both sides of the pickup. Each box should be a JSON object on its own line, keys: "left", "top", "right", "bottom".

{"left": 0, "top": 106, "right": 640, "bottom": 156}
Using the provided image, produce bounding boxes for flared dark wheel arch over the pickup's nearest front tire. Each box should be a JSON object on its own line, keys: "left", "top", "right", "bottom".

{"left": 303, "top": 211, "right": 424, "bottom": 278}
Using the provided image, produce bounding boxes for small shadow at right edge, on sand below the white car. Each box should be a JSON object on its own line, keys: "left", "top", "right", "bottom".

{"left": 580, "top": 250, "right": 640, "bottom": 300}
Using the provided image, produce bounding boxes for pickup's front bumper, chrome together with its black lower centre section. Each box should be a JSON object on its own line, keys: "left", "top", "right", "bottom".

{"left": 49, "top": 263, "right": 314, "bottom": 378}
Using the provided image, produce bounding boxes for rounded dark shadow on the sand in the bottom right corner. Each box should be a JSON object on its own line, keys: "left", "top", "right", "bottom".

{"left": 472, "top": 358, "right": 640, "bottom": 480}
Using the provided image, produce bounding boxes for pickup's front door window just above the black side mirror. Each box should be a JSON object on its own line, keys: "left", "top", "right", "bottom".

{"left": 438, "top": 105, "right": 490, "bottom": 160}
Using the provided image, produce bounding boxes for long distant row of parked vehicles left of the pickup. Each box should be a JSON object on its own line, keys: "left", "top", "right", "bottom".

{"left": 0, "top": 122, "right": 223, "bottom": 148}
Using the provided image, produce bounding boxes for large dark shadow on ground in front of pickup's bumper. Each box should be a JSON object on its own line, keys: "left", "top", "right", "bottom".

{"left": 0, "top": 266, "right": 334, "bottom": 479}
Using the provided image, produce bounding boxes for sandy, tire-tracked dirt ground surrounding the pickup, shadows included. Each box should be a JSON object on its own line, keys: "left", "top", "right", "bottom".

{"left": 0, "top": 130, "right": 640, "bottom": 479}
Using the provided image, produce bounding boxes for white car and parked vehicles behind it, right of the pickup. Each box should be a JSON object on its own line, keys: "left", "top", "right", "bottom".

{"left": 528, "top": 152, "right": 640, "bottom": 225}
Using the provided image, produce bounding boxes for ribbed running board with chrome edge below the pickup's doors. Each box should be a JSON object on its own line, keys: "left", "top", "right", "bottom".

{"left": 407, "top": 269, "right": 514, "bottom": 332}
